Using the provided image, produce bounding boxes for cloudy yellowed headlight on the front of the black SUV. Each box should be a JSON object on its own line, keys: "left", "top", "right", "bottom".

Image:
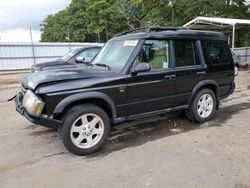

{"left": 22, "top": 90, "right": 44, "bottom": 117}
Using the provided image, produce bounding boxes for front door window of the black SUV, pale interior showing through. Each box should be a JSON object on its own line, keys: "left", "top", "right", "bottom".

{"left": 136, "top": 40, "right": 169, "bottom": 70}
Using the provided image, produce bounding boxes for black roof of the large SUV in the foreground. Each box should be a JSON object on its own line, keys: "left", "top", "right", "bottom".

{"left": 111, "top": 28, "right": 225, "bottom": 40}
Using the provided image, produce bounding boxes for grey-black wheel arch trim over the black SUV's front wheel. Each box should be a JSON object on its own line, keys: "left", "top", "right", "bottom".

{"left": 53, "top": 91, "right": 117, "bottom": 118}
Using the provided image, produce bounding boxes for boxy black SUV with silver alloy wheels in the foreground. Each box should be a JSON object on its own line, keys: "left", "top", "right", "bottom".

{"left": 16, "top": 27, "right": 235, "bottom": 155}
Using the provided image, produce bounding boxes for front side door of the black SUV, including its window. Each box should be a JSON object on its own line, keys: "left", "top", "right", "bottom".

{"left": 128, "top": 39, "right": 175, "bottom": 115}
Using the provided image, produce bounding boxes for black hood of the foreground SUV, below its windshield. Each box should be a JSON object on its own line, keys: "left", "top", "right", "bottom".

{"left": 22, "top": 67, "right": 111, "bottom": 90}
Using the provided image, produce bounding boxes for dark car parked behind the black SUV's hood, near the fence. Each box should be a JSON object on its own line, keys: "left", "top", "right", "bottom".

{"left": 31, "top": 46, "right": 101, "bottom": 73}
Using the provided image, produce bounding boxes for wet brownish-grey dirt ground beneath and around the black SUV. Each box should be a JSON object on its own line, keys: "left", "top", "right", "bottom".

{"left": 0, "top": 71, "right": 250, "bottom": 188}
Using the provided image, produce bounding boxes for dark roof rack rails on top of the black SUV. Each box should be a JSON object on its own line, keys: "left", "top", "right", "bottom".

{"left": 115, "top": 26, "right": 189, "bottom": 37}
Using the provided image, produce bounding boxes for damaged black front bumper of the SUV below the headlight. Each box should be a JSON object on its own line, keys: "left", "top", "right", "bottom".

{"left": 15, "top": 92, "right": 63, "bottom": 129}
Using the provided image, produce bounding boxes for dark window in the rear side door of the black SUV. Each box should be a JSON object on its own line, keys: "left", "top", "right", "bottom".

{"left": 174, "top": 40, "right": 200, "bottom": 67}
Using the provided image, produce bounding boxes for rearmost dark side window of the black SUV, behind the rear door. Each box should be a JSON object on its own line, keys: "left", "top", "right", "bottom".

{"left": 205, "top": 41, "right": 230, "bottom": 65}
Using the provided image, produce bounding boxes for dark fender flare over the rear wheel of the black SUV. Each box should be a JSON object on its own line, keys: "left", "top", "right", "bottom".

{"left": 188, "top": 80, "right": 219, "bottom": 104}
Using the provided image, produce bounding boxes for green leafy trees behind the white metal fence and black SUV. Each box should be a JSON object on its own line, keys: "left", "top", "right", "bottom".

{"left": 41, "top": 0, "right": 250, "bottom": 45}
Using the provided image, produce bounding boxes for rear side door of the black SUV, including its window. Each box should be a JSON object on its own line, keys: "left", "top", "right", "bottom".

{"left": 173, "top": 39, "right": 206, "bottom": 106}
